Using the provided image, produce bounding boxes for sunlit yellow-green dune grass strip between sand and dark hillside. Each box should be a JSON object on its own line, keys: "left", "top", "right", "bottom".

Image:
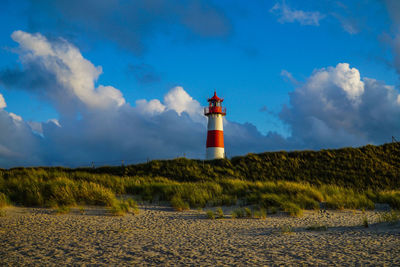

{"left": 0, "top": 172, "right": 400, "bottom": 217}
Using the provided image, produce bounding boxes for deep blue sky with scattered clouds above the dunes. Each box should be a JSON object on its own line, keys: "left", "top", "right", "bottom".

{"left": 0, "top": 0, "right": 400, "bottom": 168}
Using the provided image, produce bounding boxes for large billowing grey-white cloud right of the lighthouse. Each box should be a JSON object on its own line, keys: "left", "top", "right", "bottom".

{"left": 280, "top": 63, "right": 400, "bottom": 148}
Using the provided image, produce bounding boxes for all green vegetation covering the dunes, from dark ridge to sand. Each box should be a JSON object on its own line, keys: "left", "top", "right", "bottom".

{"left": 0, "top": 143, "right": 400, "bottom": 217}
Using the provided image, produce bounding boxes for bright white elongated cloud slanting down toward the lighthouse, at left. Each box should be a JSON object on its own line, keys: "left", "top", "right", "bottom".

{"left": 11, "top": 31, "right": 125, "bottom": 110}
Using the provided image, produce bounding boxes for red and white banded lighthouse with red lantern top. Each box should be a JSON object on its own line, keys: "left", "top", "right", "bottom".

{"left": 204, "top": 91, "right": 226, "bottom": 159}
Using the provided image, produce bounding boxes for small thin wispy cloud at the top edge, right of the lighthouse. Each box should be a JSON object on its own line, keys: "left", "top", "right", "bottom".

{"left": 270, "top": 1, "right": 325, "bottom": 26}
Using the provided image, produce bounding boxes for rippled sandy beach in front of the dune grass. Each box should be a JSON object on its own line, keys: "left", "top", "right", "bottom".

{"left": 0, "top": 205, "right": 400, "bottom": 266}
